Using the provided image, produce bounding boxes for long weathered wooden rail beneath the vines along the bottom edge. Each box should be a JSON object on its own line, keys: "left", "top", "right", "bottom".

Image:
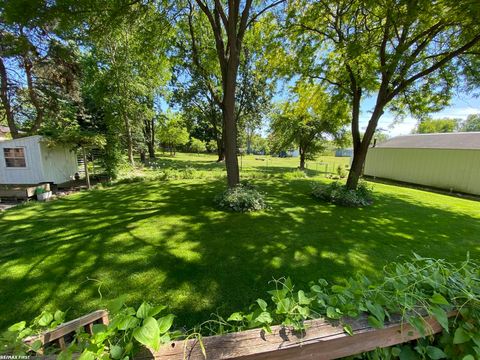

{"left": 136, "top": 317, "right": 450, "bottom": 360}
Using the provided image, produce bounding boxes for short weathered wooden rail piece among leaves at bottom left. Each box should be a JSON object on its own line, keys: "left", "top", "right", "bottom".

{"left": 24, "top": 310, "right": 108, "bottom": 344}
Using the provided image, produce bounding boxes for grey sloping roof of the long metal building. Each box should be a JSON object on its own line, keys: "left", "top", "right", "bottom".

{"left": 376, "top": 132, "right": 480, "bottom": 150}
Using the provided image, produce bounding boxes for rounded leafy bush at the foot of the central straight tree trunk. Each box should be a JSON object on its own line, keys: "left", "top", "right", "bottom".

{"left": 215, "top": 183, "right": 267, "bottom": 212}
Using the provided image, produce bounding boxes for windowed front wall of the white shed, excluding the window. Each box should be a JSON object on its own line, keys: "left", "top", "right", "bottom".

{"left": 0, "top": 136, "right": 43, "bottom": 184}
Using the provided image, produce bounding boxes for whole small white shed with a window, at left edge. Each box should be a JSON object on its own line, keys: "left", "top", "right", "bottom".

{"left": 0, "top": 135, "right": 78, "bottom": 184}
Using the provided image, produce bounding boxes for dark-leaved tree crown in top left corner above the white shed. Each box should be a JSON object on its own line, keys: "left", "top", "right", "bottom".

{"left": 0, "top": 2, "right": 80, "bottom": 138}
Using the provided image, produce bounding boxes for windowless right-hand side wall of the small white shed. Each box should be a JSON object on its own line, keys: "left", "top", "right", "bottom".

{"left": 40, "top": 142, "right": 78, "bottom": 184}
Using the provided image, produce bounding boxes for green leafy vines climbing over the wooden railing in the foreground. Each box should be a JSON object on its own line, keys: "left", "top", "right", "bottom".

{"left": 0, "top": 254, "right": 480, "bottom": 360}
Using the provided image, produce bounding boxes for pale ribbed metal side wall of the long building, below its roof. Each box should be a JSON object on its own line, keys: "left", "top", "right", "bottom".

{"left": 364, "top": 147, "right": 480, "bottom": 195}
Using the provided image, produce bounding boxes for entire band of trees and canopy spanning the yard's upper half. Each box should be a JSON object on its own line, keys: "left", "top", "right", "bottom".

{"left": 0, "top": 0, "right": 480, "bottom": 188}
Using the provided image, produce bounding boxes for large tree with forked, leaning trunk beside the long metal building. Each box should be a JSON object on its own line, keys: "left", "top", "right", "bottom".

{"left": 291, "top": 0, "right": 480, "bottom": 189}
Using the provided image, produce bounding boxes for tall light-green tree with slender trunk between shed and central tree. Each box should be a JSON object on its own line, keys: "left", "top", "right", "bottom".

{"left": 80, "top": 3, "right": 171, "bottom": 165}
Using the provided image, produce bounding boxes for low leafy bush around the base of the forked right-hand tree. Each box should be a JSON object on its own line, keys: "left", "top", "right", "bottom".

{"left": 312, "top": 181, "right": 373, "bottom": 207}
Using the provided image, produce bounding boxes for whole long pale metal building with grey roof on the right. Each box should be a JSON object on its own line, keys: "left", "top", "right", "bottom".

{"left": 364, "top": 132, "right": 480, "bottom": 195}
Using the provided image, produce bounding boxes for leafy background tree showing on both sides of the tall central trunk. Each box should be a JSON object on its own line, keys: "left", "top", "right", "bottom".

{"left": 172, "top": 2, "right": 274, "bottom": 161}
